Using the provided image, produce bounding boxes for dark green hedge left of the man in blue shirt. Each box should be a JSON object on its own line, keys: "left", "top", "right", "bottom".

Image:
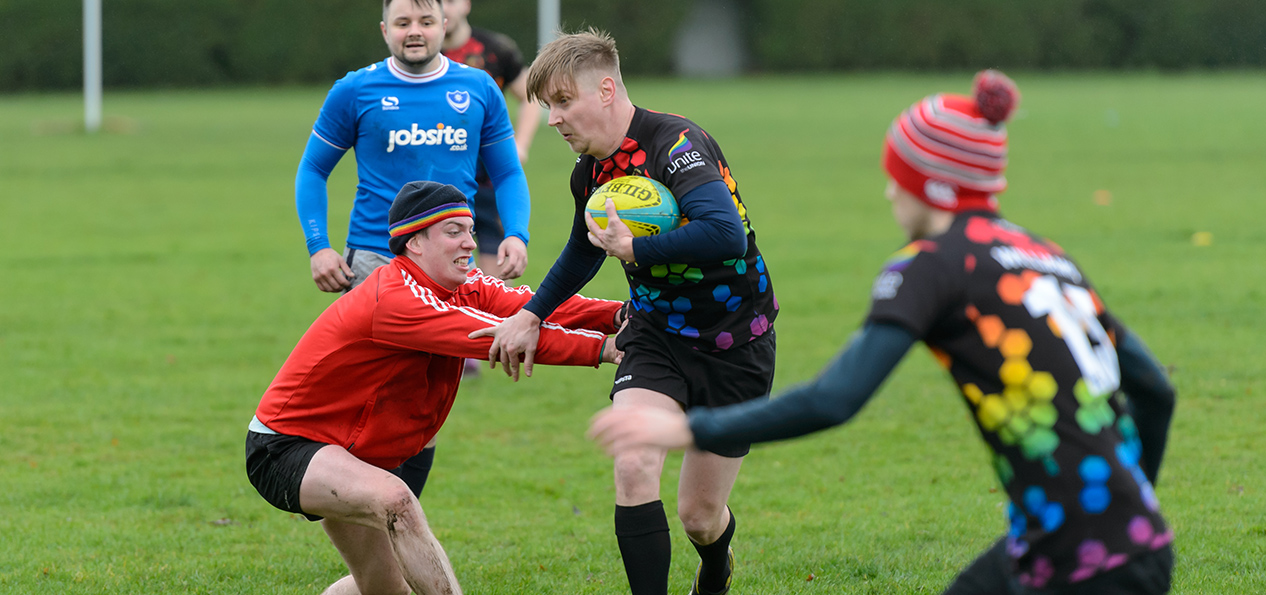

{"left": 0, "top": 0, "right": 385, "bottom": 90}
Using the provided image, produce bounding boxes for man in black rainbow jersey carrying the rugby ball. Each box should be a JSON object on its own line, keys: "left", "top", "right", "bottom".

{"left": 473, "top": 29, "right": 779, "bottom": 595}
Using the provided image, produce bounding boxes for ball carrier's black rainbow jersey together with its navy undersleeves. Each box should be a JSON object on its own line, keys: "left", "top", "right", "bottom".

{"left": 524, "top": 108, "right": 779, "bottom": 352}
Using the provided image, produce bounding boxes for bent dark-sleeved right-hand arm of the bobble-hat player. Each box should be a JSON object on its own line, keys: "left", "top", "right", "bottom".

{"left": 1117, "top": 330, "right": 1176, "bottom": 484}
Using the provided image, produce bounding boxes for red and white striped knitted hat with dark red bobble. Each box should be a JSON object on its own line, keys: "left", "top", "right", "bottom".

{"left": 884, "top": 70, "right": 1020, "bottom": 213}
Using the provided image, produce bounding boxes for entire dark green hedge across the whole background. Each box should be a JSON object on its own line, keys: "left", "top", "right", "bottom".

{"left": 0, "top": 0, "right": 1266, "bottom": 91}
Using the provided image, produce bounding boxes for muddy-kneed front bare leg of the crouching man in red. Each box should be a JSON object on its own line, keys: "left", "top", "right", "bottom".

{"left": 299, "top": 446, "right": 461, "bottom": 595}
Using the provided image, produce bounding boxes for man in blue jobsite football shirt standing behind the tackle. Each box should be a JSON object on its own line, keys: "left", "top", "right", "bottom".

{"left": 295, "top": 0, "right": 529, "bottom": 291}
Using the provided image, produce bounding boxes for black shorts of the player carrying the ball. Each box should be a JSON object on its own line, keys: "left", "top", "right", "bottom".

{"left": 611, "top": 320, "right": 776, "bottom": 458}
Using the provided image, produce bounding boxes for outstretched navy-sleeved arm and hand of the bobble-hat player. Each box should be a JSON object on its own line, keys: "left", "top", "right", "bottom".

{"left": 589, "top": 324, "right": 915, "bottom": 453}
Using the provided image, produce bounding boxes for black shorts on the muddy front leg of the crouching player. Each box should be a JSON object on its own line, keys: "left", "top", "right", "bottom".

{"left": 246, "top": 432, "right": 329, "bottom": 520}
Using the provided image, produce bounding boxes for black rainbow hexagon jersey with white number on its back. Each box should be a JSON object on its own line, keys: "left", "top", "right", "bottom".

{"left": 868, "top": 213, "right": 1172, "bottom": 589}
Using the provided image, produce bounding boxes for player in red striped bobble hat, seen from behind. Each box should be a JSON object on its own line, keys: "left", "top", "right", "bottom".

{"left": 591, "top": 71, "right": 1175, "bottom": 595}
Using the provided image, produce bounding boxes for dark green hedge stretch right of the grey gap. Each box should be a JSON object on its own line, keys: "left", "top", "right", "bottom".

{"left": 746, "top": 0, "right": 1266, "bottom": 70}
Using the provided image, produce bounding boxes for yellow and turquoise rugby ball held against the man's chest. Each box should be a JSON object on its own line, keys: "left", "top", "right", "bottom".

{"left": 585, "top": 176, "right": 682, "bottom": 237}
